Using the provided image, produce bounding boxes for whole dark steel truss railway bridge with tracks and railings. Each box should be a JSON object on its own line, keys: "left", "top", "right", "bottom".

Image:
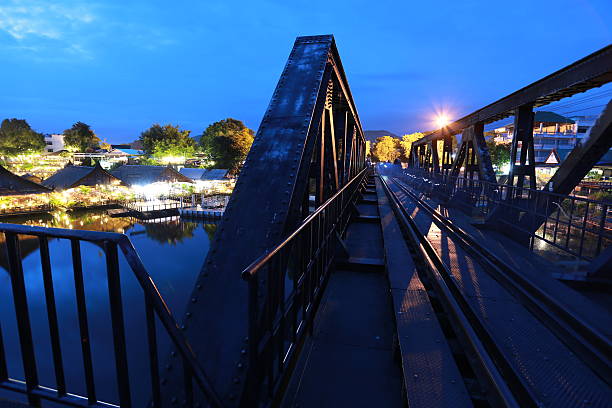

{"left": 0, "top": 36, "right": 612, "bottom": 407}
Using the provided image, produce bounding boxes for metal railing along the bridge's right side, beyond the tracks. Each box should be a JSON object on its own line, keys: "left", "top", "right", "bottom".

{"left": 393, "top": 169, "right": 612, "bottom": 260}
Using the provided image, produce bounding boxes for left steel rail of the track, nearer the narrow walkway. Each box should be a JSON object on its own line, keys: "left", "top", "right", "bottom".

{"left": 380, "top": 177, "right": 539, "bottom": 407}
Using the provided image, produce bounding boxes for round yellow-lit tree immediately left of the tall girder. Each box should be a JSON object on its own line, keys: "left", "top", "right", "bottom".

{"left": 200, "top": 118, "right": 255, "bottom": 173}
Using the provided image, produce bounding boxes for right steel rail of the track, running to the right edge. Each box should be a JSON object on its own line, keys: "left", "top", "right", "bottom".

{"left": 394, "top": 179, "right": 612, "bottom": 385}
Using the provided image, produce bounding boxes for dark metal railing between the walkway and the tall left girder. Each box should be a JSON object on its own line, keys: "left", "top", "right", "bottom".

{"left": 242, "top": 169, "right": 367, "bottom": 401}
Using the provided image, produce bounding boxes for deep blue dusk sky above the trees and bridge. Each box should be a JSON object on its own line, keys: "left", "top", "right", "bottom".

{"left": 0, "top": 0, "right": 612, "bottom": 143}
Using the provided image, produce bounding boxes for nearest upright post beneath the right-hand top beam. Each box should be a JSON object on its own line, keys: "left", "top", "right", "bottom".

{"left": 508, "top": 103, "right": 536, "bottom": 189}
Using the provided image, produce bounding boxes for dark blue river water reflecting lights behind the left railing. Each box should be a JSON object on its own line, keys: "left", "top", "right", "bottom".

{"left": 0, "top": 211, "right": 216, "bottom": 406}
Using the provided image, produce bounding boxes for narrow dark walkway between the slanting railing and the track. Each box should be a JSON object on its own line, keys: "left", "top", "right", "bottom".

{"left": 283, "top": 175, "right": 404, "bottom": 407}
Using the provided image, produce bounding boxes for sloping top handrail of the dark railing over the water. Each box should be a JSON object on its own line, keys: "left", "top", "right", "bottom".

{"left": 0, "top": 223, "right": 223, "bottom": 407}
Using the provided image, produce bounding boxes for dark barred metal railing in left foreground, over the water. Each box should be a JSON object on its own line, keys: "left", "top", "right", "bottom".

{"left": 0, "top": 224, "right": 222, "bottom": 407}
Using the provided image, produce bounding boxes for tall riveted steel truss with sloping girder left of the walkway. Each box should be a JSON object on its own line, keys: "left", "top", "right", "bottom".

{"left": 164, "top": 35, "right": 365, "bottom": 406}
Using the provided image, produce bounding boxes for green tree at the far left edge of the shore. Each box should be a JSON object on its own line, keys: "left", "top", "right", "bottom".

{"left": 0, "top": 119, "right": 45, "bottom": 156}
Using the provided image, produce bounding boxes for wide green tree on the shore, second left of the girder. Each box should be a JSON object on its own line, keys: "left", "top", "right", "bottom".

{"left": 139, "top": 123, "right": 196, "bottom": 160}
